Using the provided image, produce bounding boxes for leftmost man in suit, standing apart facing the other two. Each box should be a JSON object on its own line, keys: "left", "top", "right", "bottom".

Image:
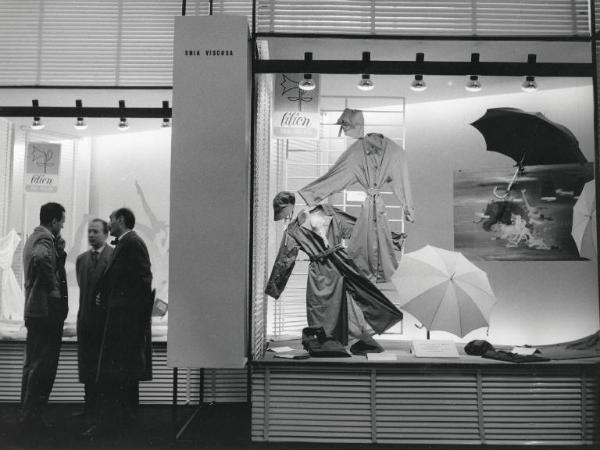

{"left": 19, "top": 203, "right": 69, "bottom": 432}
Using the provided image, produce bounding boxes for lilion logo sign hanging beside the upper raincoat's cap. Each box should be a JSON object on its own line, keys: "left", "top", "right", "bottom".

{"left": 273, "top": 73, "right": 320, "bottom": 139}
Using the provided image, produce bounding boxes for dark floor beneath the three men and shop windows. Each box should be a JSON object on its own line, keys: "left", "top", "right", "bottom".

{"left": 0, "top": 404, "right": 594, "bottom": 450}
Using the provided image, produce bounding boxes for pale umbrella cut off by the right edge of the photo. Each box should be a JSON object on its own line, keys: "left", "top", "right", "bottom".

{"left": 571, "top": 180, "right": 598, "bottom": 259}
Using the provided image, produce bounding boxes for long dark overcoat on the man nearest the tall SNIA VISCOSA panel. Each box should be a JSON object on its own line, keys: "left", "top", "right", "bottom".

{"left": 96, "top": 231, "right": 153, "bottom": 383}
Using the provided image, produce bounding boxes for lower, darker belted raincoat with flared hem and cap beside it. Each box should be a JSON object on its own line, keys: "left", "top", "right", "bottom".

{"left": 266, "top": 192, "right": 402, "bottom": 351}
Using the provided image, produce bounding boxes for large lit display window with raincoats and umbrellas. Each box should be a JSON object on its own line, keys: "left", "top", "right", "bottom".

{"left": 253, "top": 39, "right": 598, "bottom": 357}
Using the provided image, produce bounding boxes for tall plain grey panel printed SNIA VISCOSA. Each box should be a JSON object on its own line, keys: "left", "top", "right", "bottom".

{"left": 168, "top": 15, "right": 252, "bottom": 368}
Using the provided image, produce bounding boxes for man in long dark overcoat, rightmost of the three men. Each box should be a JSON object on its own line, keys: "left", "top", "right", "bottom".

{"left": 96, "top": 208, "right": 153, "bottom": 432}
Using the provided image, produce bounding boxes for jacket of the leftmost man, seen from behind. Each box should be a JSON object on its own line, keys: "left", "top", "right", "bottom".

{"left": 23, "top": 226, "right": 68, "bottom": 319}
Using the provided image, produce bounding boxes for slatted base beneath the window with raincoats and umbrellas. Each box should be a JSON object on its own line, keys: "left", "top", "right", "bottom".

{"left": 252, "top": 341, "right": 600, "bottom": 446}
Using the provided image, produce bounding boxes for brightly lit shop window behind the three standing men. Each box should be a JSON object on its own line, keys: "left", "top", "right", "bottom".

{"left": 0, "top": 95, "right": 171, "bottom": 341}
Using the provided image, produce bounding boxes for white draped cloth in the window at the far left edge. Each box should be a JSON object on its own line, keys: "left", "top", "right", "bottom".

{"left": 0, "top": 229, "right": 25, "bottom": 320}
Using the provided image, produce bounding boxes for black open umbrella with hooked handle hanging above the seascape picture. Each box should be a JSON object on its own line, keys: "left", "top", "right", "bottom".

{"left": 471, "top": 108, "right": 587, "bottom": 198}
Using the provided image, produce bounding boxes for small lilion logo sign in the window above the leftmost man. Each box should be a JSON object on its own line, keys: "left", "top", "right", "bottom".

{"left": 25, "top": 142, "right": 60, "bottom": 192}
